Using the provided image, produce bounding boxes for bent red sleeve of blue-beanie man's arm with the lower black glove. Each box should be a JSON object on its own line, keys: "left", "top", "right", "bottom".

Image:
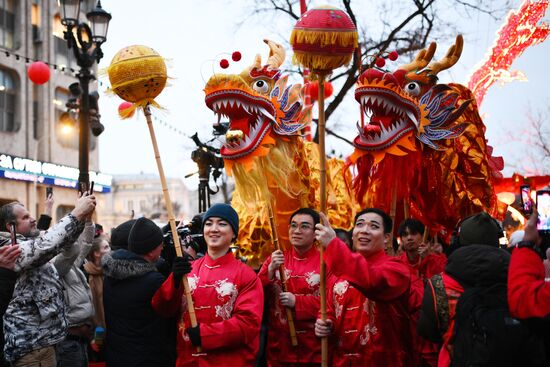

{"left": 199, "top": 270, "right": 264, "bottom": 350}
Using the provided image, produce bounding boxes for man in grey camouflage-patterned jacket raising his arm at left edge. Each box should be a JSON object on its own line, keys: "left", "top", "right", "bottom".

{"left": 0, "top": 195, "right": 96, "bottom": 367}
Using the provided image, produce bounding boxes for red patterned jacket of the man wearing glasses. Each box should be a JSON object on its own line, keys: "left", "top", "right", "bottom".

{"left": 258, "top": 247, "right": 321, "bottom": 363}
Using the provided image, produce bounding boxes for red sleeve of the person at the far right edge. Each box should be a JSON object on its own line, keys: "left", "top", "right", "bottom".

{"left": 508, "top": 248, "right": 550, "bottom": 318}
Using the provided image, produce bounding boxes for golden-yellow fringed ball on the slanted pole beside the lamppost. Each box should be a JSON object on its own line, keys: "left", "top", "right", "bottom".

{"left": 107, "top": 45, "right": 168, "bottom": 117}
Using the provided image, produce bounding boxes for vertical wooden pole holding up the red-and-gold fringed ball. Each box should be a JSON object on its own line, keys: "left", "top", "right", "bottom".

{"left": 317, "top": 73, "right": 328, "bottom": 367}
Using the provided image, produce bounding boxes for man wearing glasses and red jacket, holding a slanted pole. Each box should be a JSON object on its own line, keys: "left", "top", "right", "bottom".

{"left": 259, "top": 208, "right": 321, "bottom": 367}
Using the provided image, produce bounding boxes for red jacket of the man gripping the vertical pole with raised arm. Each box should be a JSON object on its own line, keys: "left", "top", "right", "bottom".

{"left": 324, "top": 238, "right": 422, "bottom": 367}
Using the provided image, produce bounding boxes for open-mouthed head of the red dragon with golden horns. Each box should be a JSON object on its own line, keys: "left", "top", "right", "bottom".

{"left": 351, "top": 35, "right": 470, "bottom": 164}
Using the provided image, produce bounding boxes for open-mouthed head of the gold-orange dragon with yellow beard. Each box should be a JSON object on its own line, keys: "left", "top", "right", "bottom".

{"left": 204, "top": 40, "right": 311, "bottom": 160}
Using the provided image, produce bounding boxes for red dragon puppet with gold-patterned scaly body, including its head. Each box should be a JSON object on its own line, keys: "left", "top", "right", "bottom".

{"left": 348, "top": 36, "right": 503, "bottom": 233}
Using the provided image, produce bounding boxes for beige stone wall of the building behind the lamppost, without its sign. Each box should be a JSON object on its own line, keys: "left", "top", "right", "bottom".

{"left": 0, "top": 0, "right": 107, "bottom": 220}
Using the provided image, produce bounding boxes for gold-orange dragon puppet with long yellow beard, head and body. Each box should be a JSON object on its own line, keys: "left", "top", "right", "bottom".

{"left": 205, "top": 40, "right": 353, "bottom": 267}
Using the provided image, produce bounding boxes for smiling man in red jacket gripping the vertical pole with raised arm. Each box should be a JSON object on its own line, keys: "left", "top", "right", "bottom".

{"left": 315, "top": 208, "right": 422, "bottom": 367}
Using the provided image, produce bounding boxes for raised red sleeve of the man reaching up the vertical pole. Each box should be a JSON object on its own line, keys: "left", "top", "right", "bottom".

{"left": 324, "top": 238, "right": 411, "bottom": 301}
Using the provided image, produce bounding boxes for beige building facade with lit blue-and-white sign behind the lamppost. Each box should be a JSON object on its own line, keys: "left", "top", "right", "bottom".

{"left": 0, "top": 0, "right": 111, "bottom": 220}
